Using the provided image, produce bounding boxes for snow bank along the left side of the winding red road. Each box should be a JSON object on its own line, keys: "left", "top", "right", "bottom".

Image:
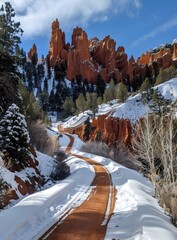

{"left": 0, "top": 134, "right": 95, "bottom": 240}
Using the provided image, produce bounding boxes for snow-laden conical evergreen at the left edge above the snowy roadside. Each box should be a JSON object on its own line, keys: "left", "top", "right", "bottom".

{"left": 0, "top": 104, "right": 30, "bottom": 166}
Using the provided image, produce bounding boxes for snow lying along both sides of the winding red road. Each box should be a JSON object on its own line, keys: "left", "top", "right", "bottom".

{"left": 0, "top": 132, "right": 177, "bottom": 240}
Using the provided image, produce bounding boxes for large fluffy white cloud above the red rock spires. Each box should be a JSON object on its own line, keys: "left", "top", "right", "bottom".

{"left": 1, "top": 0, "right": 141, "bottom": 37}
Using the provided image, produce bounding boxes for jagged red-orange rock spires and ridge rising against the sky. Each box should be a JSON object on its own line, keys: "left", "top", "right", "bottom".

{"left": 49, "top": 19, "right": 177, "bottom": 83}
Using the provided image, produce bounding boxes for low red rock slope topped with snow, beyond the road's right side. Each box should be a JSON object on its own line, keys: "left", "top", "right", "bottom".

{"left": 59, "top": 78, "right": 177, "bottom": 147}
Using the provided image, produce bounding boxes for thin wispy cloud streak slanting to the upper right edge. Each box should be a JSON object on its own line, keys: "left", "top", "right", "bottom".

{"left": 132, "top": 16, "right": 177, "bottom": 47}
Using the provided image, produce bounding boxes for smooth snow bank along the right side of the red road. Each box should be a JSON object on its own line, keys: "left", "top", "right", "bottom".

{"left": 72, "top": 149, "right": 177, "bottom": 240}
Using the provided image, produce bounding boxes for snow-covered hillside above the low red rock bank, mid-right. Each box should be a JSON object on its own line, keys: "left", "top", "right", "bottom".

{"left": 63, "top": 78, "right": 177, "bottom": 128}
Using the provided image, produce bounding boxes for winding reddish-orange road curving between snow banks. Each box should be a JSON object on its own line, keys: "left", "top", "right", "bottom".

{"left": 40, "top": 135, "right": 115, "bottom": 240}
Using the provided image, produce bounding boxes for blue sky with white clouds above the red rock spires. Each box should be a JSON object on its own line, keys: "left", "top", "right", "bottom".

{"left": 1, "top": 0, "right": 177, "bottom": 59}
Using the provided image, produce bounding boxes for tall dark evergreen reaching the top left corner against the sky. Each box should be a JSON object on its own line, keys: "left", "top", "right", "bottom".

{"left": 0, "top": 2, "right": 23, "bottom": 115}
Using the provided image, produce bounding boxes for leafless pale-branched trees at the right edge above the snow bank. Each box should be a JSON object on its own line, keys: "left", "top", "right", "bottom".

{"left": 132, "top": 113, "right": 177, "bottom": 195}
